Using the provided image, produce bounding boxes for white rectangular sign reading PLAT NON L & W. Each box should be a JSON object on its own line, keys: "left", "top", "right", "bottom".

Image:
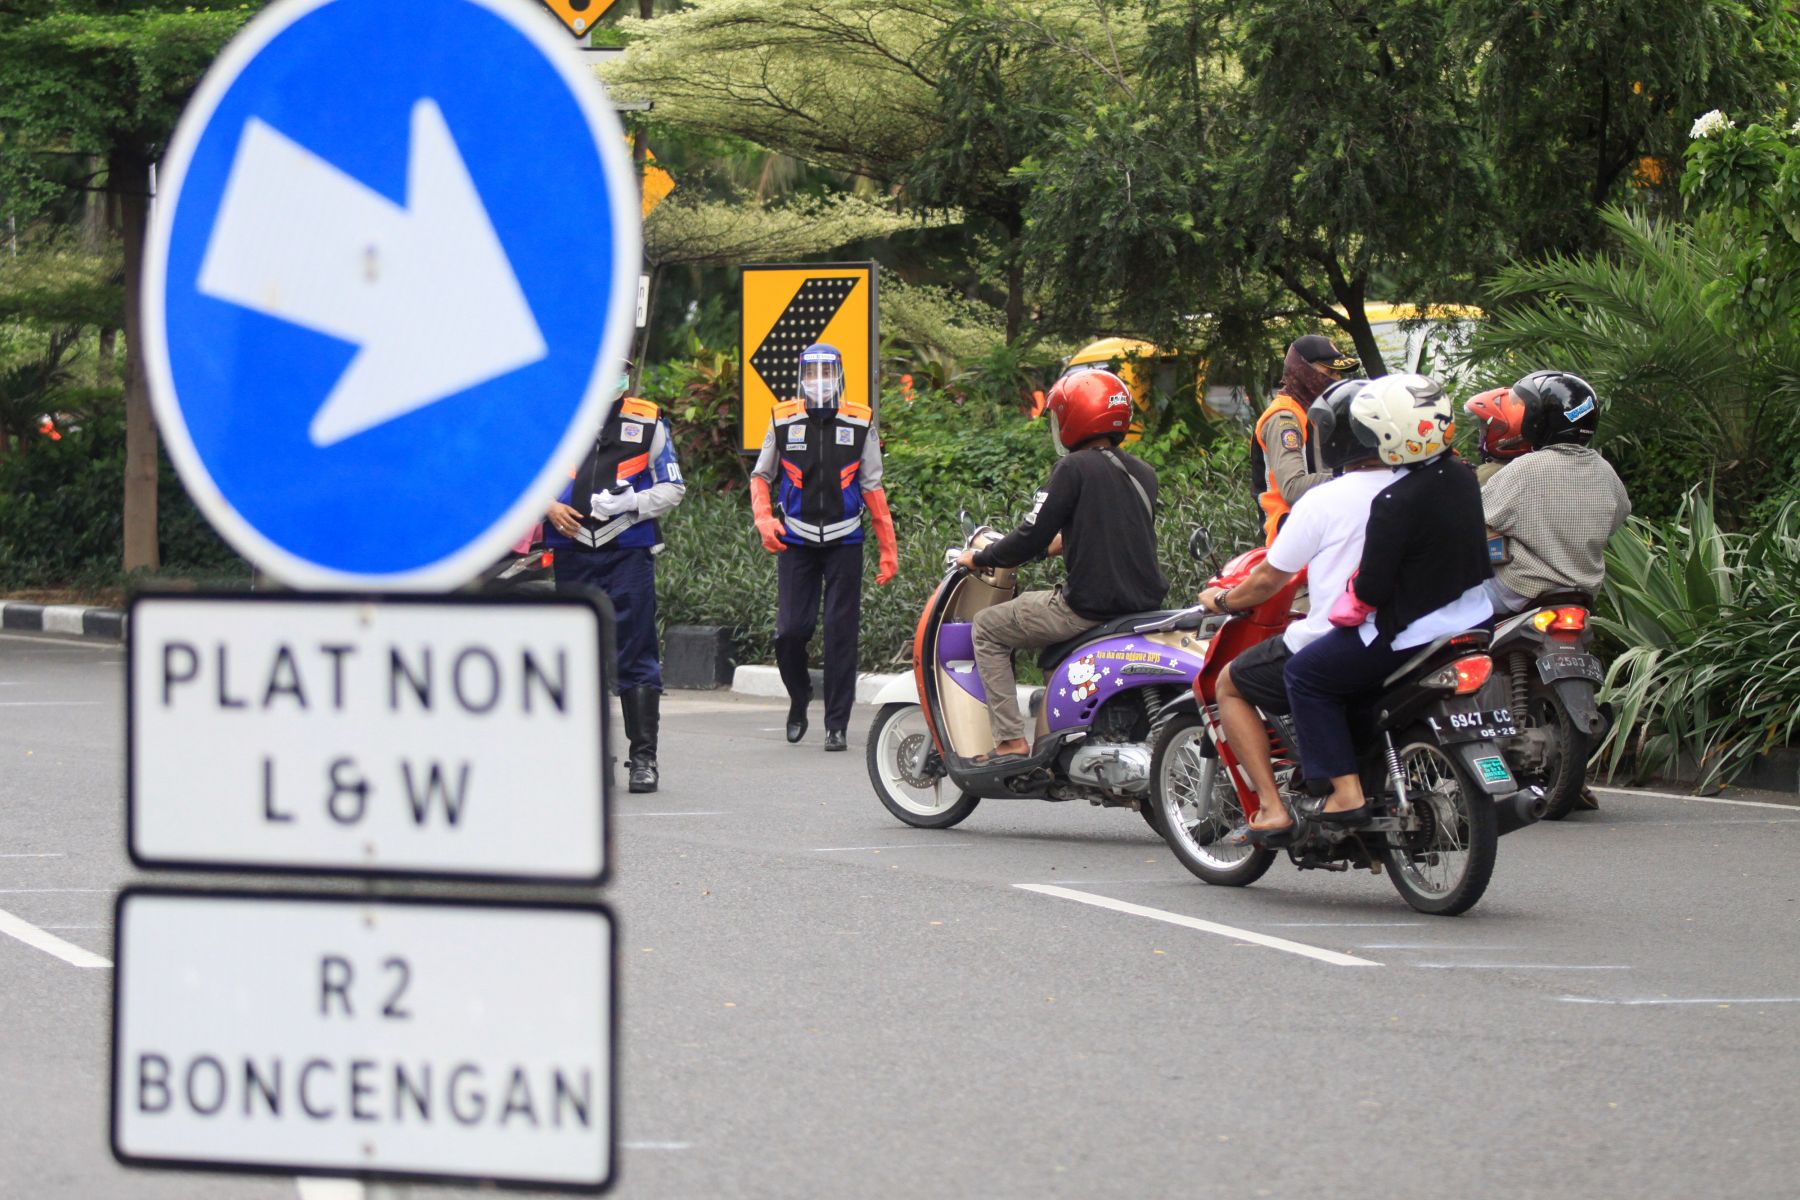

{"left": 126, "top": 594, "right": 608, "bottom": 883}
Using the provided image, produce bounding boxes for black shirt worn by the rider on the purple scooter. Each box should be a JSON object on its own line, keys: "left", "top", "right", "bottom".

{"left": 976, "top": 446, "right": 1168, "bottom": 621}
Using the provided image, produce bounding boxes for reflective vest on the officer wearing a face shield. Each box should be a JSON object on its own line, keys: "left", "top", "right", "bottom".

{"left": 774, "top": 399, "right": 875, "bottom": 545}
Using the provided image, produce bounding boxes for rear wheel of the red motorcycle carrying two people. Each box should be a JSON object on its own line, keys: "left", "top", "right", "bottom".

{"left": 1382, "top": 725, "right": 1499, "bottom": 916}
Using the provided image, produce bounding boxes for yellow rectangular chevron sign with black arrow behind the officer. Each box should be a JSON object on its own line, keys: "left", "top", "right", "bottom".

{"left": 738, "top": 263, "right": 877, "bottom": 453}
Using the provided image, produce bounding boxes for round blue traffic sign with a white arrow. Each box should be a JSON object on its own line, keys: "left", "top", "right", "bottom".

{"left": 142, "top": 0, "right": 641, "bottom": 590}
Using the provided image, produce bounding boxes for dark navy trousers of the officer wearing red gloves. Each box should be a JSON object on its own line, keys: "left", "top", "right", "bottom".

{"left": 776, "top": 542, "right": 862, "bottom": 730}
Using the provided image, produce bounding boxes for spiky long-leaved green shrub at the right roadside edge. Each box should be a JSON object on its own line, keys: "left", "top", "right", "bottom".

{"left": 1598, "top": 495, "right": 1800, "bottom": 788}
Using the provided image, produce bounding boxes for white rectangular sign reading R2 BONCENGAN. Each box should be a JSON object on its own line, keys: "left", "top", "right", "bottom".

{"left": 112, "top": 889, "right": 616, "bottom": 1191}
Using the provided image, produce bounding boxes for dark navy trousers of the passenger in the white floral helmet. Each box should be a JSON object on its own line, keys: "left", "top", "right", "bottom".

{"left": 1283, "top": 630, "right": 1418, "bottom": 795}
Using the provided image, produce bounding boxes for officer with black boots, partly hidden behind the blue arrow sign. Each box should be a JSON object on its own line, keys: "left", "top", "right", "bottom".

{"left": 544, "top": 376, "right": 688, "bottom": 792}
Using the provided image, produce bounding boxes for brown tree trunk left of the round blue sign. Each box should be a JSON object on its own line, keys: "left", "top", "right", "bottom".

{"left": 106, "top": 149, "right": 162, "bottom": 570}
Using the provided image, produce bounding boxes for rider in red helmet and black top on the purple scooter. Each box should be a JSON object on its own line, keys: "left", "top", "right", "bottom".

{"left": 958, "top": 371, "right": 1168, "bottom": 761}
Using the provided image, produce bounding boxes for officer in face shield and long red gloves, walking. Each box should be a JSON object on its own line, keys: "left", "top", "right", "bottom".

{"left": 751, "top": 344, "right": 900, "bottom": 750}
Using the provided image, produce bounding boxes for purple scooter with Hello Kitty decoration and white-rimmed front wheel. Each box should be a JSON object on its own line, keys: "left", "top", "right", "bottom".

{"left": 869, "top": 518, "right": 1208, "bottom": 831}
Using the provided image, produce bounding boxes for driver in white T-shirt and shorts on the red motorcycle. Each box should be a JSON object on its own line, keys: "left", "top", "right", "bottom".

{"left": 1201, "top": 380, "right": 1395, "bottom": 846}
